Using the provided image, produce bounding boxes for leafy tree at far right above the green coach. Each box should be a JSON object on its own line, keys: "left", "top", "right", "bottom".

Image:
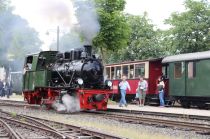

{"left": 165, "top": 0, "right": 210, "bottom": 53}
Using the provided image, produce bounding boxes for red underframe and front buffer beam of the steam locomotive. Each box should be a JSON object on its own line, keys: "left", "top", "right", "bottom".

{"left": 23, "top": 88, "right": 111, "bottom": 110}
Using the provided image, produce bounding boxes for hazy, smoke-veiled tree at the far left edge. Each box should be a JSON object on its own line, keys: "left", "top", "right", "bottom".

{"left": 0, "top": 8, "right": 41, "bottom": 69}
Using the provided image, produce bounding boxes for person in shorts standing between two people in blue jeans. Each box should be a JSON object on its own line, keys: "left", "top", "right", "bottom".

{"left": 136, "top": 76, "right": 148, "bottom": 106}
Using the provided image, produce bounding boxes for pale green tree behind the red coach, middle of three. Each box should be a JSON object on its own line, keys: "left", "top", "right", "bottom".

{"left": 106, "top": 13, "right": 163, "bottom": 63}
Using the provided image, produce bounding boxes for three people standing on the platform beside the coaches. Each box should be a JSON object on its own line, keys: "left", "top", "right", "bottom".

{"left": 119, "top": 75, "right": 165, "bottom": 107}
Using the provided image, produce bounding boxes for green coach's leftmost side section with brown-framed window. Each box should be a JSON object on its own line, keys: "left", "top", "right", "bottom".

{"left": 169, "top": 62, "right": 186, "bottom": 96}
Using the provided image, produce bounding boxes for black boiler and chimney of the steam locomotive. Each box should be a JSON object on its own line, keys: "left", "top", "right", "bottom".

{"left": 49, "top": 45, "right": 104, "bottom": 88}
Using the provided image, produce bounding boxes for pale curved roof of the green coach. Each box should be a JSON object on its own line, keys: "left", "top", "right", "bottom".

{"left": 162, "top": 51, "right": 210, "bottom": 63}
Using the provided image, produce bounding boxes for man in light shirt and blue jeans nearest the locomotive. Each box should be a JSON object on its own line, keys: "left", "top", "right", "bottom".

{"left": 119, "top": 75, "right": 131, "bottom": 107}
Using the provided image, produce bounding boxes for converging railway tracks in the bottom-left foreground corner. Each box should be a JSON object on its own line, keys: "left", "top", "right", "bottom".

{"left": 0, "top": 111, "right": 122, "bottom": 139}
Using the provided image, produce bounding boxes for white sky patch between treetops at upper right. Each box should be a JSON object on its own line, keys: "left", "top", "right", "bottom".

{"left": 125, "top": 0, "right": 185, "bottom": 29}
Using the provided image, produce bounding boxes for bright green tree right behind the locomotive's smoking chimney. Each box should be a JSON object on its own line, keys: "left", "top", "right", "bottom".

{"left": 93, "top": 0, "right": 130, "bottom": 61}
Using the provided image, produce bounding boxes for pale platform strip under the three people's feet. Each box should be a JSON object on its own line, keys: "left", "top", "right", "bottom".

{"left": 108, "top": 104, "right": 210, "bottom": 117}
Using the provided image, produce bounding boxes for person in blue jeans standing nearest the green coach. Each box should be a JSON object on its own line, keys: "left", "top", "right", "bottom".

{"left": 157, "top": 77, "right": 165, "bottom": 107}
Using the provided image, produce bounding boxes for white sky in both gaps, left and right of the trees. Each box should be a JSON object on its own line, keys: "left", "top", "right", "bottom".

{"left": 12, "top": 0, "right": 185, "bottom": 50}
